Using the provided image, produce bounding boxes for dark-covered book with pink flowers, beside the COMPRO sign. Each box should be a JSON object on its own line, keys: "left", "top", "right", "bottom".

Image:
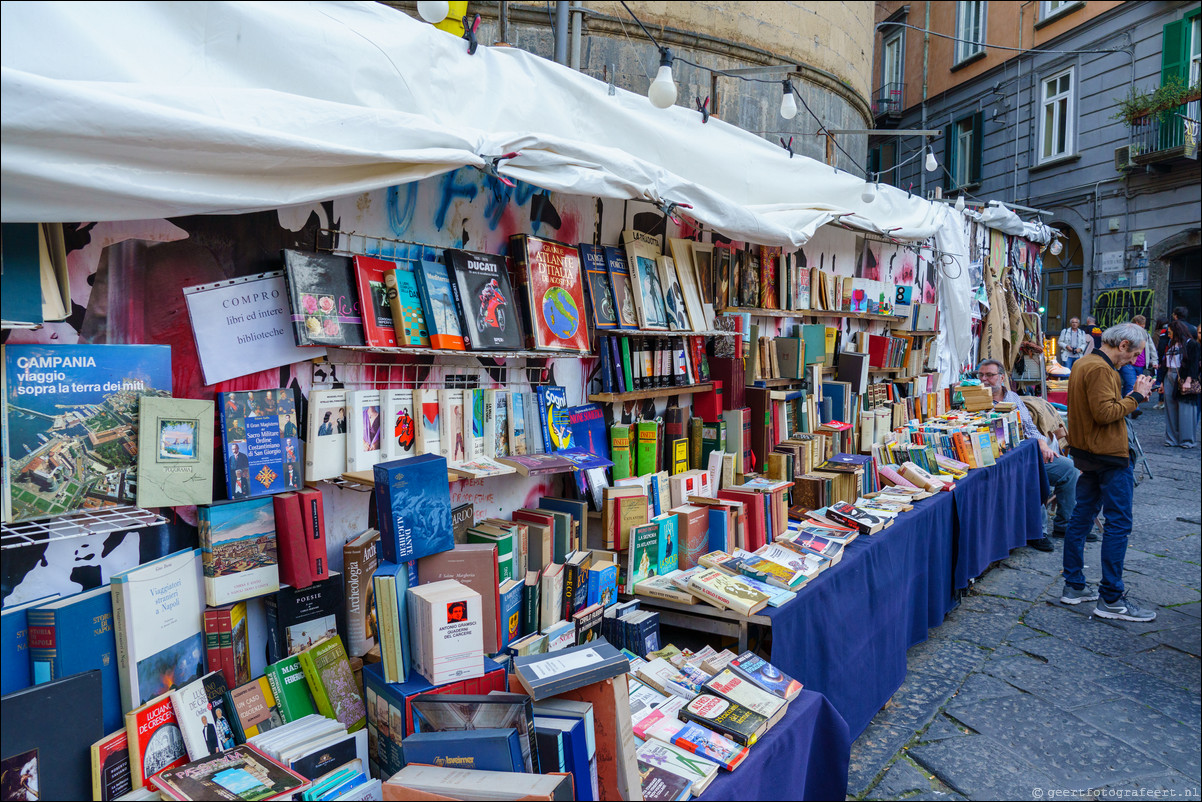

{"left": 284, "top": 250, "right": 367, "bottom": 346}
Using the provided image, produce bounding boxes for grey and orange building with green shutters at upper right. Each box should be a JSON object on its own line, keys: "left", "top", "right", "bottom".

{"left": 868, "top": 0, "right": 1202, "bottom": 333}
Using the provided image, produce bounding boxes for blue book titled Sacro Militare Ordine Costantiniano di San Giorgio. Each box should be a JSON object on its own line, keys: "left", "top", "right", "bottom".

{"left": 218, "top": 387, "right": 304, "bottom": 499}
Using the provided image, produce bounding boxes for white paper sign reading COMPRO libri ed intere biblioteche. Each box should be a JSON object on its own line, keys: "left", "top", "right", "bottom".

{"left": 184, "top": 271, "right": 326, "bottom": 385}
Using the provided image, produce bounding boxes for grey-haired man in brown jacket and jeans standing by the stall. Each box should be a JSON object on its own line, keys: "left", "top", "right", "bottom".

{"left": 1060, "top": 323, "right": 1156, "bottom": 622}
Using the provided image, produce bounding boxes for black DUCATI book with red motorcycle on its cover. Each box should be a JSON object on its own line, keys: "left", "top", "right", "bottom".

{"left": 446, "top": 249, "right": 522, "bottom": 351}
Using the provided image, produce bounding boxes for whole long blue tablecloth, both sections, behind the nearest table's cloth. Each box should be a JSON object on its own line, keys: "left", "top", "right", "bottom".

{"left": 763, "top": 442, "right": 1046, "bottom": 738}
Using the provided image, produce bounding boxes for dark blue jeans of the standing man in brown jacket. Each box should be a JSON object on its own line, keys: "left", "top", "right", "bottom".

{"left": 1064, "top": 463, "right": 1135, "bottom": 602}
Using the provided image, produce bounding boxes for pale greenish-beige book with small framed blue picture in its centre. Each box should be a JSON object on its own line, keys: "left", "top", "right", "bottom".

{"left": 137, "top": 396, "right": 213, "bottom": 507}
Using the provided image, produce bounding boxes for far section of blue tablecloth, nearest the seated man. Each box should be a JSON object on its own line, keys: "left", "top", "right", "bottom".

{"left": 952, "top": 440, "right": 1047, "bottom": 590}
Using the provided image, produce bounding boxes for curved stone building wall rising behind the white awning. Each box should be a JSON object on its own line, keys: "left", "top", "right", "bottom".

{"left": 386, "top": 0, "right": 873, "bottom": 169}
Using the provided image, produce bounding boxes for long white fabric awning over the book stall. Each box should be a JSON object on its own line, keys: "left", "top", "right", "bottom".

{"left": 0, "top": 2, "right": 945, "bottom": 245}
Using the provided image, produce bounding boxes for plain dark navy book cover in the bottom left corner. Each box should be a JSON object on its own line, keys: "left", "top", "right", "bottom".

{"left": 0, "top": 671, "right": 103, "bottom": 800}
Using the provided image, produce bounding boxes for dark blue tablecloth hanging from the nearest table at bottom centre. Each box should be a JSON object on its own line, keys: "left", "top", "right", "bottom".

{"left": 700, "top": 690, "right": 851, "bottom": 800}
